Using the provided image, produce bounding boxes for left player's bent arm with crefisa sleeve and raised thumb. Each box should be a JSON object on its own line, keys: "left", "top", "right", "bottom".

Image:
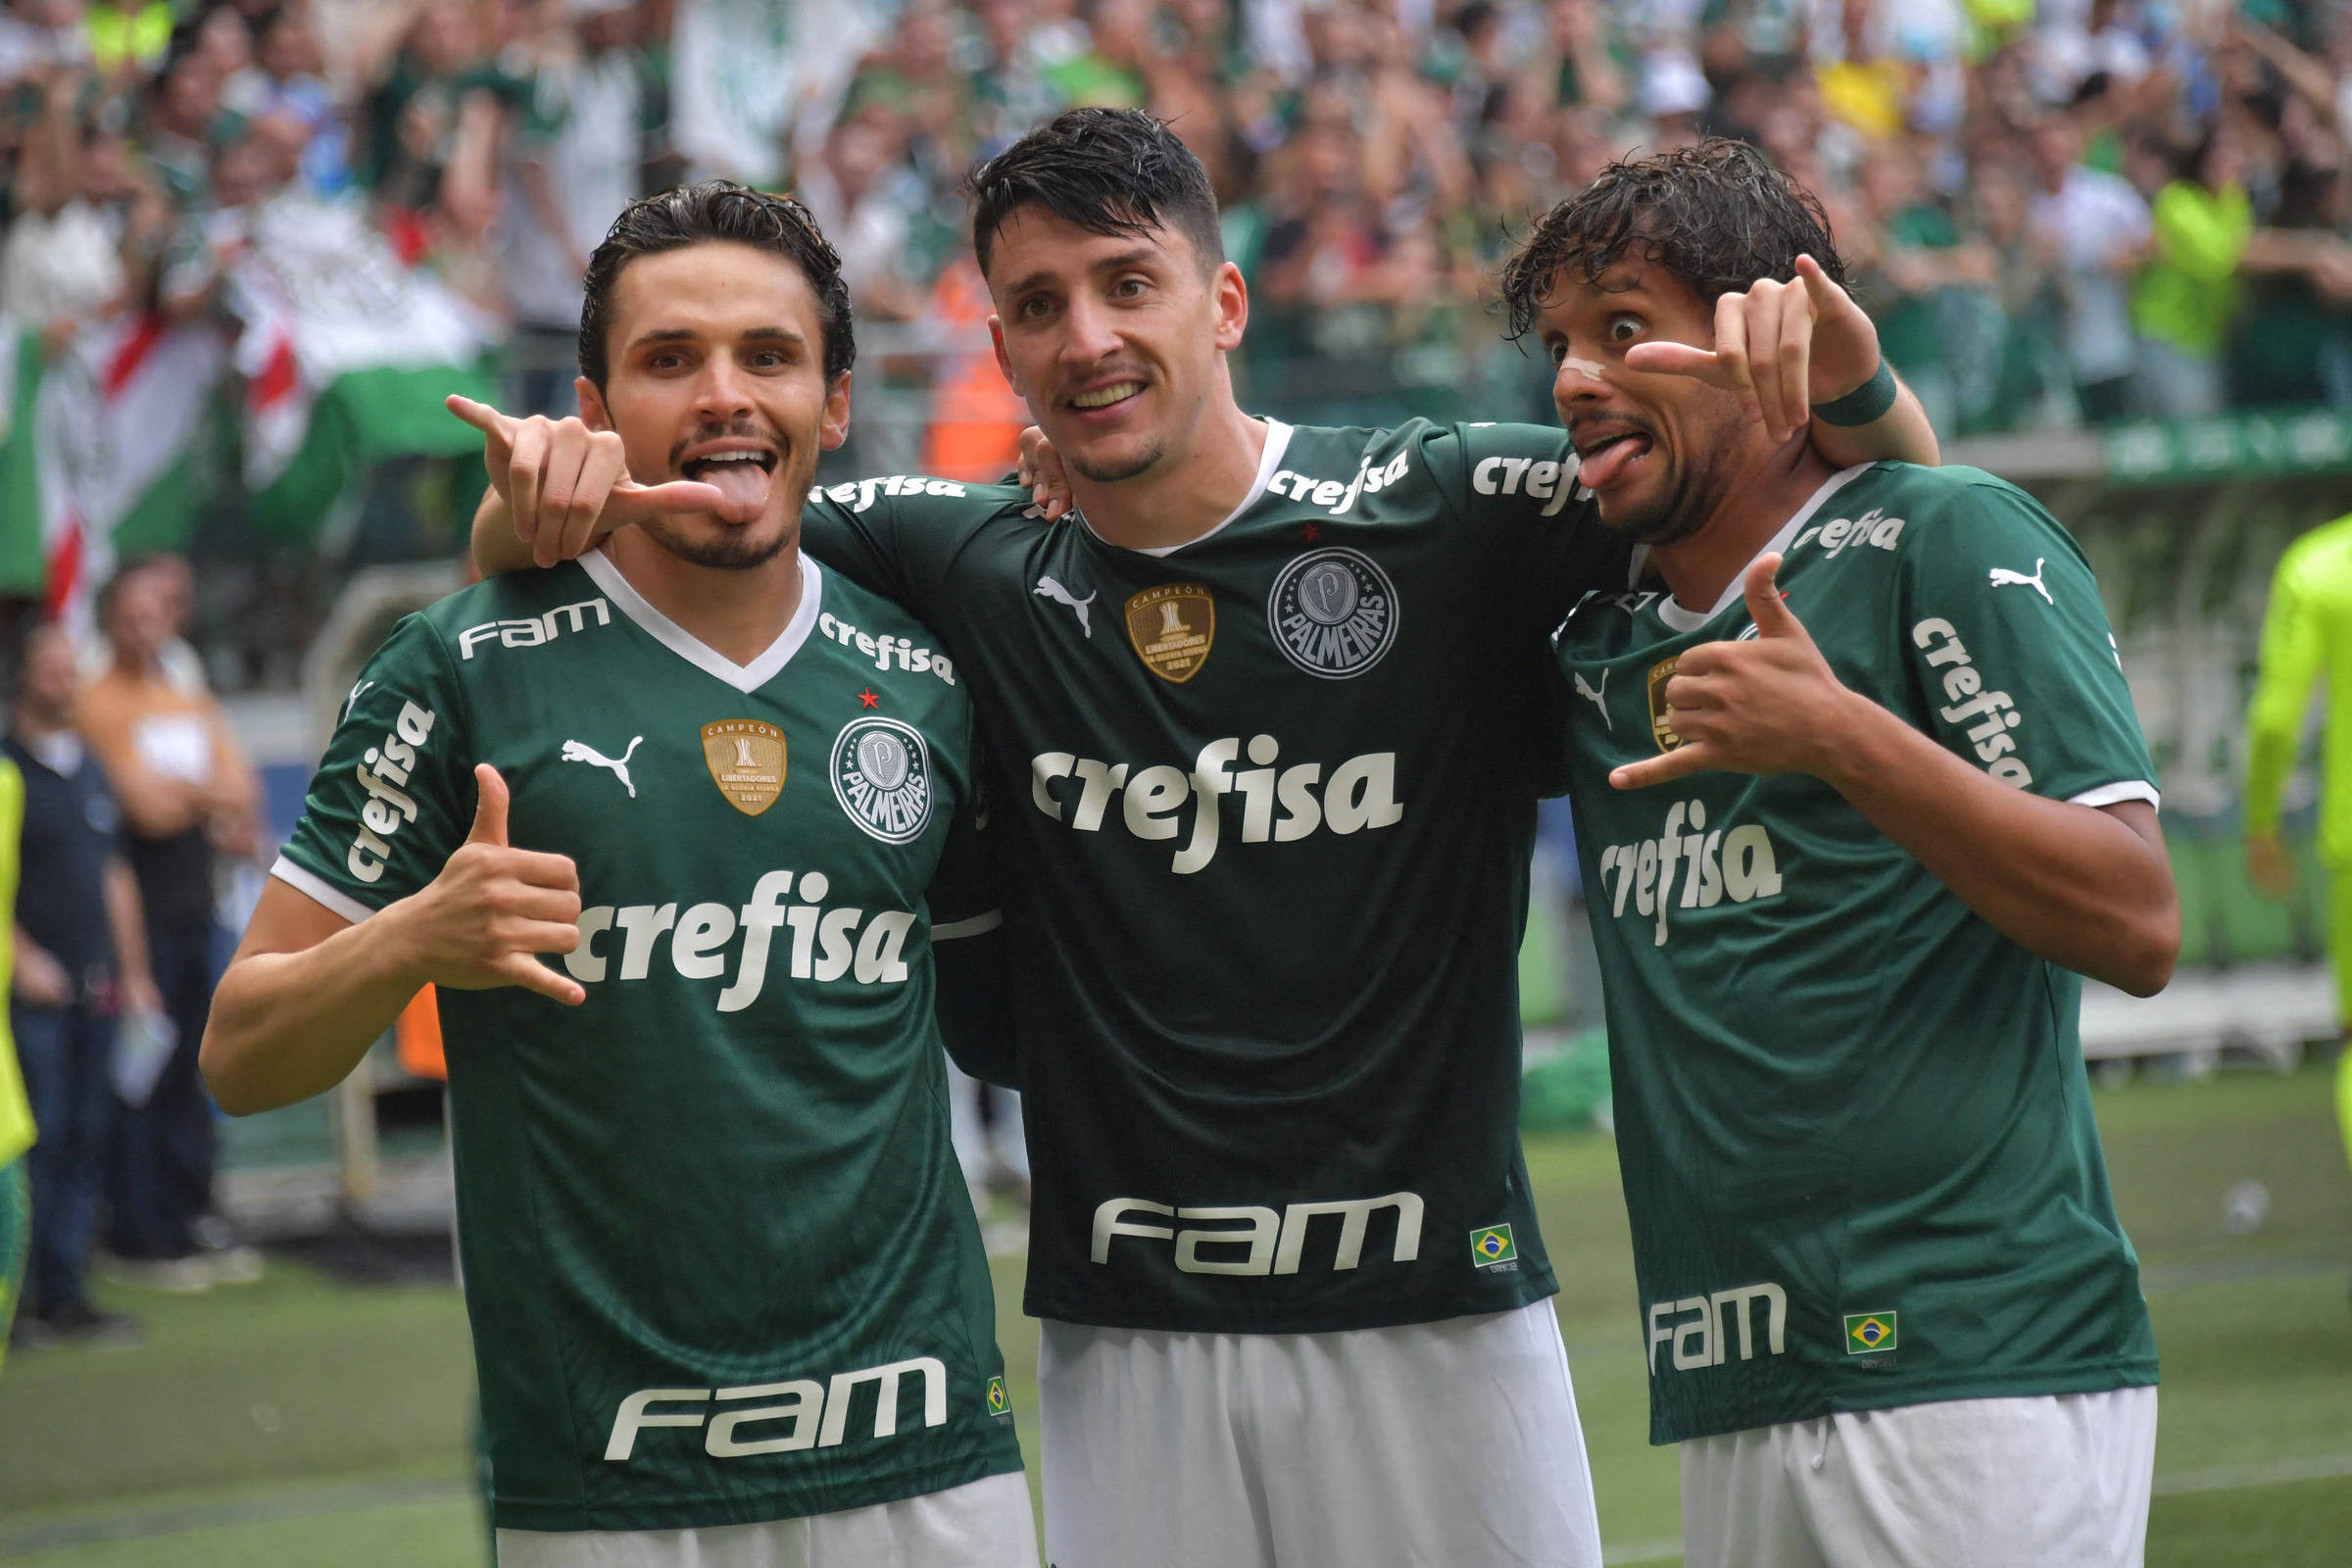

{"left": 200, "top": 615, "right": 583, "bottom": 1116}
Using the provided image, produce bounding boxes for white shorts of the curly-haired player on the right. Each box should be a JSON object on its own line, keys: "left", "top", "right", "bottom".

{"left": 1682, "top": 1387, "right": 2157, "bottom": 1568}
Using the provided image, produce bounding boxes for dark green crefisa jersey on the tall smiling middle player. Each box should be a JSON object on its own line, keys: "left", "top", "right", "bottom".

{"left": 805, "top": 423, "right": 1623, "bottom": 1333}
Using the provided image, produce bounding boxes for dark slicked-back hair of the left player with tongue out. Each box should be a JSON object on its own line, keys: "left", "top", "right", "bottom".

{"left": 581, "top": 178, "right": 858, "bottom": 393}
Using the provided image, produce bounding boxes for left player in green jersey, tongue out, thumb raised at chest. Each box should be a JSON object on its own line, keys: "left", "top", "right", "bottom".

{"left": 202, "top": 183, "right": 1037, "bottom": 1568}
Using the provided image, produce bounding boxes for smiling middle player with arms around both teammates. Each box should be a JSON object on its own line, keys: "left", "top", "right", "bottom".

{"left": 475, "top": 111, "right": 1934, "bottom": 1568}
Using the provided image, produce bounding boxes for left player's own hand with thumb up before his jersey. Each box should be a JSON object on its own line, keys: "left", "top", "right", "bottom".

{"left": 400, "top": 761, "right": 588, "bottom": 1006}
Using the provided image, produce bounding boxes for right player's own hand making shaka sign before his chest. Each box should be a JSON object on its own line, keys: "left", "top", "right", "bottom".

{"left": 1609, "top": 555, "right": 1868, "bottom": 790}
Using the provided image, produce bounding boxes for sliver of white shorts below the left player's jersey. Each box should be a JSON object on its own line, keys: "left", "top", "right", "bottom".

{"left": 499, "top": 1472, "right": 1037, "bottom": 1568}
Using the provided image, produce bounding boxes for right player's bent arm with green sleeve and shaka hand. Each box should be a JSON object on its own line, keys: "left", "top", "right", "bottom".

{"left": 1613, "top": 470, "right": 2180, "bottom": 997}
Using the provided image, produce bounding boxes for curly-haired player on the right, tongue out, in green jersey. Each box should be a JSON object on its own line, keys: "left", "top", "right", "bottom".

{"left": 1505, "top": 141, "right": 2180, "bottom": 1568}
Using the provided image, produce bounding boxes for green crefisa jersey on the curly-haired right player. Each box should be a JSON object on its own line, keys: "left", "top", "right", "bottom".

{"left": 1557, "top": 464, "right": 2157, "bottom": 1444}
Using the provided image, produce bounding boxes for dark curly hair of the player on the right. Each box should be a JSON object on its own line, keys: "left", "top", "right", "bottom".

{"left": 1503, "top": 136, "right": 1846, "bottom": 338}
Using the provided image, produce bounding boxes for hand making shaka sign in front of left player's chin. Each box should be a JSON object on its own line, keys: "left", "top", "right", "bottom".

{"left": 442, "top": 393, "right": 729, "bottom": 566}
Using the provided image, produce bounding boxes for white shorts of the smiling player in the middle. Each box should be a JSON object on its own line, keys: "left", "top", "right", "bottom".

{"left": 1037, "top": 1300, "right": 1601, "bottom": 1568}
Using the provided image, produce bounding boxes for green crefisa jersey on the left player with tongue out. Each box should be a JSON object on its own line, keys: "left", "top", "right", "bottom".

{"left": 275, "top": 555, "right": 1021, "bottom": 1531}
